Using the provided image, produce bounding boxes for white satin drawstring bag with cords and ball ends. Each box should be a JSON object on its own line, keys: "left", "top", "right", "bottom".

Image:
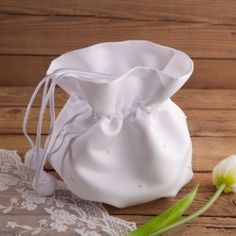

{"left": 23, "top": 40, "right": 193, "bottom": 207}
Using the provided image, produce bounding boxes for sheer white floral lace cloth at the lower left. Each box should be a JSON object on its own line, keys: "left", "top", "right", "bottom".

{"left": 0, "top": 149, "right": 136, "bottom": 236}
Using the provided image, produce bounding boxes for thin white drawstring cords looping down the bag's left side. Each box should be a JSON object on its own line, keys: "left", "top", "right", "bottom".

{"left": 23, "top": 69, "right": 115, "bottom": 193}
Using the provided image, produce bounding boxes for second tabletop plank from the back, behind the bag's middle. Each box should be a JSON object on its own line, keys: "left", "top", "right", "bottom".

{"left": 0, "top": 107, "right": 236, "bottom": 137}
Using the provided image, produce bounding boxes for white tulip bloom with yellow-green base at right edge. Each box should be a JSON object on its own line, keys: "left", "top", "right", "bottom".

{"left": 212, "top": 155, "right": 236, "bottom": 193}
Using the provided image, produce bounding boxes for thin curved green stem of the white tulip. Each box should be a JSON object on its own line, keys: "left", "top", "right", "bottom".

{"left": 151, "top": 184, "right": 225, "bottom": 236}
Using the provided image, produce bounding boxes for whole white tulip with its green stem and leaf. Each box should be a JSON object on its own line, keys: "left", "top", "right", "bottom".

{"left": 128, "top": 155, "right": 236, "bottom": 236}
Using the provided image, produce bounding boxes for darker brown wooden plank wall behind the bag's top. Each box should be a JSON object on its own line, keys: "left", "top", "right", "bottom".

{"left": 0, "top": 0, "right": 236, "bottom": 88}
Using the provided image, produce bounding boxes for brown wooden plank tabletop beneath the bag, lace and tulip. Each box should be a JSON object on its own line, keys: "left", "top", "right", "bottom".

{"left": 0, "top": 87, "right": 236, "bottom": 235}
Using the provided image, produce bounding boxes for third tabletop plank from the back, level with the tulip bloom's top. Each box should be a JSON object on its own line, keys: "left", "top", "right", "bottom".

{"left": 0, "top": 134, "right": 236, "bottom": 172}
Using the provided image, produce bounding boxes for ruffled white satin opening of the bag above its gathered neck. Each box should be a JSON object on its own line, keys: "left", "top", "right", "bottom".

{"left": 47, "top": 40, "right": 193, "bottom": 115}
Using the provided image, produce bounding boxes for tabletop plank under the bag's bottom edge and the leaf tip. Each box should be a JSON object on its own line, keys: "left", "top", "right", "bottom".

{"left": 32, "top": 172, "right": 236, "bottom": 217}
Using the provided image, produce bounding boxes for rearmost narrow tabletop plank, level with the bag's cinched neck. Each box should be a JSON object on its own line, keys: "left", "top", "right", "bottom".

{"left": 0, "top": 87, "right": 236, "bottom": 110}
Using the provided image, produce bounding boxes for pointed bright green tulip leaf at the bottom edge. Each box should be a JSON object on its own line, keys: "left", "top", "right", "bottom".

{"left": 128, "top": 184, "right": 199, "bottom": 236}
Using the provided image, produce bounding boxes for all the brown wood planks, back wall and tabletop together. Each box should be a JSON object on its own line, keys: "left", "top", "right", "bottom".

{"left": 0, "top": 0, "right": 236, "bottom": 236}
